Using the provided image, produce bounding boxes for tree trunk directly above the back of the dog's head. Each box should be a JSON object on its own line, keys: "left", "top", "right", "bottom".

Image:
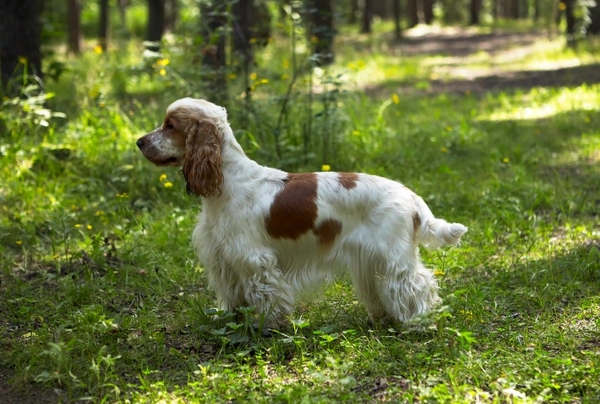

{"left": 200, "top": 0, "right": 228, "bottom": 106}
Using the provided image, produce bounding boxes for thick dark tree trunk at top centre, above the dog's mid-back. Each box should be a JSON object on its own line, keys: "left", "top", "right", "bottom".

{"left": 310, "top": 0, "right": 335, "bottom": 66}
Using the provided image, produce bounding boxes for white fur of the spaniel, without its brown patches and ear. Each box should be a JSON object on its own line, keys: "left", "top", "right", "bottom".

{"left": 140, "top": 98, "right": 467, "bottom": 326}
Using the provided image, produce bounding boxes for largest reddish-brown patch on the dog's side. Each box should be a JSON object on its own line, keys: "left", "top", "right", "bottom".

{"left": 265, "top": 173, "right": 317, "bottom": 240}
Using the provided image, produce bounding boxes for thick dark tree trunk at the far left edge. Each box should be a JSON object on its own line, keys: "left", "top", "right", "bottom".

{"left": 0, "top": 0, "right": 42, "bottom": 89}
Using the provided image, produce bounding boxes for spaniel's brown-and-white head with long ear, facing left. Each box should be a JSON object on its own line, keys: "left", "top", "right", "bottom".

{"left": 136, "top": 98, "right": 227, "bottom": 197}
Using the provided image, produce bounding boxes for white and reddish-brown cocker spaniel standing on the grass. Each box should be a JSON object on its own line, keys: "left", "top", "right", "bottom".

{"left": 137, "top": 98, "right": 467, "bottom": 327}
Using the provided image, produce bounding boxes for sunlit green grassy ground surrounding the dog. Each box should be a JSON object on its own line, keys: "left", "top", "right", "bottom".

{"left": 0, "top": 23, "right": 600, "bottom": 403}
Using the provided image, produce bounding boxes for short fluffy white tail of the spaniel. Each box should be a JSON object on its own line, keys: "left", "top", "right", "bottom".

{"left": 413, "top": 195, "right": 469, "bottom": 248}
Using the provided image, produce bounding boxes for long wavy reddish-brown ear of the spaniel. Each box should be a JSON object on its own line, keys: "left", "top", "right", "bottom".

{"left": 182, "top": 120, "right": 223, "bottom": 198}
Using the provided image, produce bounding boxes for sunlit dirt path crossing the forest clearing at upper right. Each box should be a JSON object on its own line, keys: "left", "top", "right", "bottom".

{"left": 365, "top": 29, "right": 600, "bottom": 96}
